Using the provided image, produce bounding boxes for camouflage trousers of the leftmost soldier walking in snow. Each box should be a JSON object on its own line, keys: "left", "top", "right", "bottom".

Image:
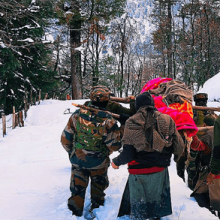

{"left": 68, "top": 165, "right": 109, "bottom": 216}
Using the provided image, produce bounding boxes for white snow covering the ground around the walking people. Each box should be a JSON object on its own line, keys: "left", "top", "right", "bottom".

{"left": 0, "top": 73, "right": 220, "bottom": 220}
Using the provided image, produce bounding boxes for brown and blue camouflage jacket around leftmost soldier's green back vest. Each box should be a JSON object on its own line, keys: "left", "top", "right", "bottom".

{"left": 61, "top": 109, "right": 121, "bottom": 169}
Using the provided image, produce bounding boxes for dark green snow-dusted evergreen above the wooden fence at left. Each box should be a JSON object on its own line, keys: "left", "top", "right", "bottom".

{"left": 0, "top": 0, "right": 56, "bottom": 114}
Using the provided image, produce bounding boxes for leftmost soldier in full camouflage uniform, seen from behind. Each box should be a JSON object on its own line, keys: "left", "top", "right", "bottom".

{"left": 61, "top": 88, "right": 121, "bottom": 216}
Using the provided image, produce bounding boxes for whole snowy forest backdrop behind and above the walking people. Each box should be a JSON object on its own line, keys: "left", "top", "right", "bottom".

{"left": 0, "top": 0, "right": 220, "bottom": 114}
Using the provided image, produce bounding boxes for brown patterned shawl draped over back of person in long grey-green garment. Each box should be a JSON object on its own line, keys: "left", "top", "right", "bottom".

{"left": 122, "top": 106, "right": 185, "bottom": 161}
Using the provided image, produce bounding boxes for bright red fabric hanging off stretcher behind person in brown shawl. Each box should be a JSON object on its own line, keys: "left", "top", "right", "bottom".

{"left": 158, "top": 107, "right": 198, "bottom": 137}
